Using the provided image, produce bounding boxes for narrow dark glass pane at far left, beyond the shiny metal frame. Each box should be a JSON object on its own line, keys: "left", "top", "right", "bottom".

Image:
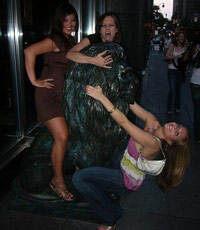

{"left": 0, "top": 0, "right": 18, "bottom": 150}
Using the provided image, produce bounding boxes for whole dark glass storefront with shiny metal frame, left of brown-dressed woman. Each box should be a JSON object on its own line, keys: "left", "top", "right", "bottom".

{"left": 0, "top": 0, "right": 69, "bottom": 160}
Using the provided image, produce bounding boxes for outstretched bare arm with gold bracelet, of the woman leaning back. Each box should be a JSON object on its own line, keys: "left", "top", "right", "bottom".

{"left": 86, "top": 86, "right": 157, "bottom": 155}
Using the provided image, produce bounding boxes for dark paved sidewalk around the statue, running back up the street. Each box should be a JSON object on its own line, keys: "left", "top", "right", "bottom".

{"left": 0, "top": 50, "right": 200, "bottom": 230}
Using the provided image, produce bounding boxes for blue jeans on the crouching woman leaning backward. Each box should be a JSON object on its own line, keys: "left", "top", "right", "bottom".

{"left": 72, "top": 167, "right": 127, "bottom": 225}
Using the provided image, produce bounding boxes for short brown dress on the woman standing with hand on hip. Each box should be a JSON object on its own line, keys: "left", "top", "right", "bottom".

{"left": 35, "top": 35, "right": 74, "bottom": 122}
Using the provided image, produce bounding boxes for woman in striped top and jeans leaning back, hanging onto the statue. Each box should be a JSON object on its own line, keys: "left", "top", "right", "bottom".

{"left": 73, "top": 86, "right": 190, "bottom": 230}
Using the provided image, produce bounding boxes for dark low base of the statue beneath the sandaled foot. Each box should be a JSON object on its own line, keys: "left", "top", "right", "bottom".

{"left": 9, "top": 178, "right": 102, "bottom": 224}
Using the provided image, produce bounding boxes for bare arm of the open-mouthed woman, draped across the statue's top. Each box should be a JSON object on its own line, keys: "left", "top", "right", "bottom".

{"left": 66, "top": 38, "right": 113, "bottom": 69}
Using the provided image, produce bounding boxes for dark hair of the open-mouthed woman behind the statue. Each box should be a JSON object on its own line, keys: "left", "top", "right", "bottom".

{"left": 96, "top": 11, "right": 122, "bottom": 43}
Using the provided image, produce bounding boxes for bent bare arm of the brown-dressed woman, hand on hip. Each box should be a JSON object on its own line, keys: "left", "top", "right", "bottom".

{"left": 24, "top": 38, "right": 56, "bottom": 88}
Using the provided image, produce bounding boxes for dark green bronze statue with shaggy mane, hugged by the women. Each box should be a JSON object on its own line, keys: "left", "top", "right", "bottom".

{"left": 63, "top": 42, "right": 139, "bottom": 168}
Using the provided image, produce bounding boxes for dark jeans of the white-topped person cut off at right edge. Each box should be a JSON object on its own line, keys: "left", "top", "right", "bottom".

{"left": 190, "top": 83, "right": 200, "bottom": 140}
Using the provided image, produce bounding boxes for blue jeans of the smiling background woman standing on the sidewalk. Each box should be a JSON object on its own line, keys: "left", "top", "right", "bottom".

{"left": 167, "top": 69, "right": 182, "bottom": 111}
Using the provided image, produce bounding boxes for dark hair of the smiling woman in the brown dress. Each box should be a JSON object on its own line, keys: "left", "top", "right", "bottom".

{"left": 51, "top": 3, "right": 79, "bottom": 41}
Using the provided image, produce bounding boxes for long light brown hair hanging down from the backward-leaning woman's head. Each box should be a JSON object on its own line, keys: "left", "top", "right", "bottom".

{"left": 157, "top": 138, "right": 190, "bottom": 192}
